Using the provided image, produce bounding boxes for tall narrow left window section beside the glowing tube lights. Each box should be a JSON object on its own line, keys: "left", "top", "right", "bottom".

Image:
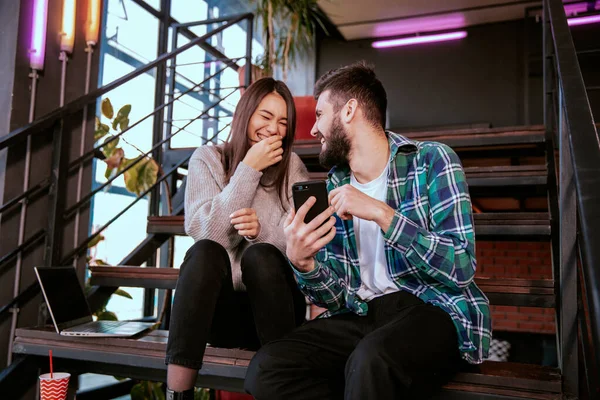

{"left": 91, "top": 0, "right": 160, "bottom": 319}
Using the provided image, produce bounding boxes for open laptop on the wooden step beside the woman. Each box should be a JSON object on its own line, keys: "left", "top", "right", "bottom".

{"left": 34, "top": 266, "right": 153, "bottom": 337}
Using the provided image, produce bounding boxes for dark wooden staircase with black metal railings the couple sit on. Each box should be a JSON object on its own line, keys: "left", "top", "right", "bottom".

{"left": 0, "top": 0, "right": 600, "bottom": 400}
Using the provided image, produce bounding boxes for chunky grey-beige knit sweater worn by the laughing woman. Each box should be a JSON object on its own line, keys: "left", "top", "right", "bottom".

{"left": 185, "top": 146, "right": 308, "bottom": 291}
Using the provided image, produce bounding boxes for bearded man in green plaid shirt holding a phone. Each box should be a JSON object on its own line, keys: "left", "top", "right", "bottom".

{"left": 246, "top": 63, "right": 491, "bottom": 400}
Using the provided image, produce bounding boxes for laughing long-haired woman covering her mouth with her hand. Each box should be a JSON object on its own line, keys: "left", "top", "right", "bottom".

{"left": 166, "top": 78, "right": 308, "bottom": 400}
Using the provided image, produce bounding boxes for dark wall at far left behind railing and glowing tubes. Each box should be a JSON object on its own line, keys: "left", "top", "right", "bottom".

{"left": 0, "top": 0, "right": 98, "bottom": 369}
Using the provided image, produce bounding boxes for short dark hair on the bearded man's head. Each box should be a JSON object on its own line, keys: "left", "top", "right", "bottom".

{"left": 315, "top": 61, "right": 387, "bottom": 128}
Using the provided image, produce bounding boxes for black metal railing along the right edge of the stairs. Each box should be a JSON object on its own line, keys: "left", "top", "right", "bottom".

{"left": 543, "top": 0, "right": 600, "bottom": 398}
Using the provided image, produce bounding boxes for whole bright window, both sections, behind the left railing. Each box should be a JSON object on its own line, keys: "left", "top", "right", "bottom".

{"left": 91, "top": 0, "right": 262, "bottom": 319}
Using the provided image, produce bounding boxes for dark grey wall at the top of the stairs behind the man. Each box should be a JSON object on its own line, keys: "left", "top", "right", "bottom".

{"left": 317, "top": 20, "right": 600, "bottom": 129}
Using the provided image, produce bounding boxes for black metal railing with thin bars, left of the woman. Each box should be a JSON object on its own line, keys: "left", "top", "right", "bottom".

{"left": 0, "top": 13, "right": 254, "bottom": 346}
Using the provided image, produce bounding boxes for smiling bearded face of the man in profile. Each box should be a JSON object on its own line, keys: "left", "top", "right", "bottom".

{"left": 310, "top": 91, "right": 351, "bottom": 168}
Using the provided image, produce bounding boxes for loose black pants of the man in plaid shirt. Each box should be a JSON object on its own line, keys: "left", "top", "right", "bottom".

{"left": 245, "top": 292, "right": 462, "bottom": 400}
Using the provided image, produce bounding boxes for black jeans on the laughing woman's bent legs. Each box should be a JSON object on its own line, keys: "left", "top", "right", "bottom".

{"left": 165, "top": 240, "right": 306, "bottom": 369}
